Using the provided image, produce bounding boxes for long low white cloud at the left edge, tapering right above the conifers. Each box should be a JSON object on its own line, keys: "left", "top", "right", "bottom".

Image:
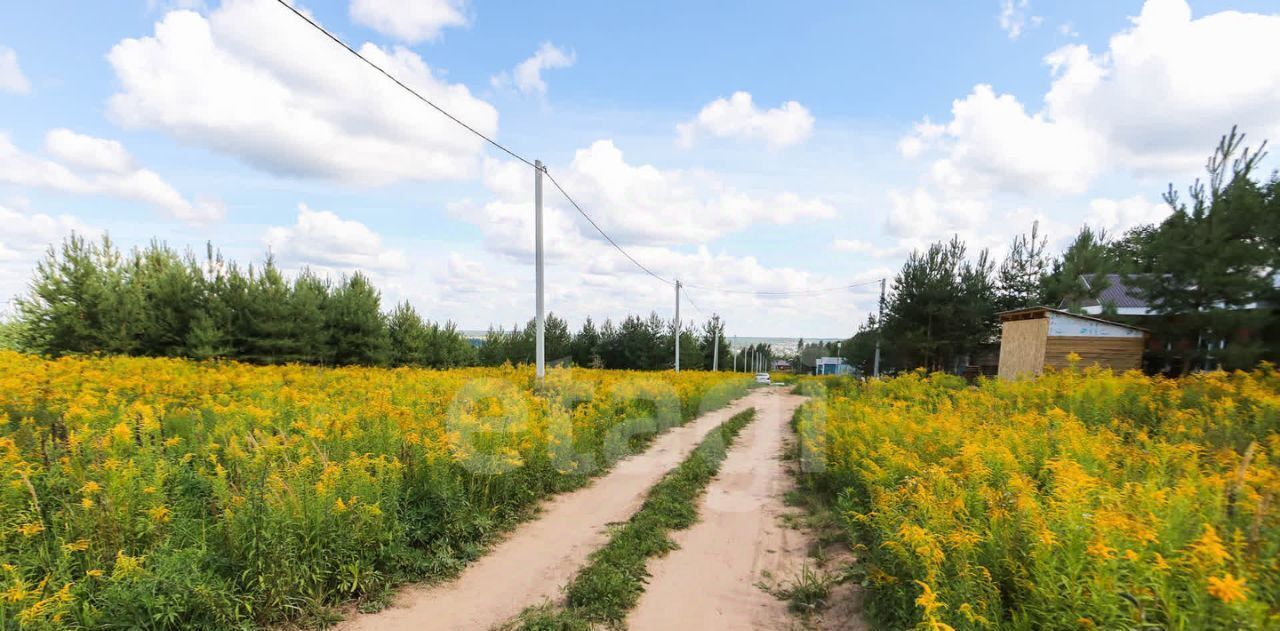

{"left": 0, "top": 129, "right": 225, "bottom": 224}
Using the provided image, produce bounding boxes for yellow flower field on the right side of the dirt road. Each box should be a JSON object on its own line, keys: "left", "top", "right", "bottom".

{"left": 797, "top": 366, "right": 1280, "bottom": 630}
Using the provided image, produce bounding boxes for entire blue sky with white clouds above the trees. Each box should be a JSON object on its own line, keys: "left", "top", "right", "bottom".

{"left": 0, "top": 0, "right": 1280, "bottom": 338}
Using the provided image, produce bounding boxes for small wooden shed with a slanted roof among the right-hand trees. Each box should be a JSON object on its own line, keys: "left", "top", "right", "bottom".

{"left": 1000, "top": 307, "right": 1147, "bottom": 379}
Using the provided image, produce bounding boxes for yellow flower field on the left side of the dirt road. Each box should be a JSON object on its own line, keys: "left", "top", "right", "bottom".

{"left": 0, "top": 352, "right": 752, "bottom": 630}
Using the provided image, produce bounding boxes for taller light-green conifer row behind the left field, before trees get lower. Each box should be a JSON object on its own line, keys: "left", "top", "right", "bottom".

{"left": 17, "top": 234, "right": 475, "bottom": 367}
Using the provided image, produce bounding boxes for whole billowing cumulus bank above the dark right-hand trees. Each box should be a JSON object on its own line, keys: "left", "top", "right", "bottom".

{"left": 888, "top": 0, "right": 1280, "bottom": 248}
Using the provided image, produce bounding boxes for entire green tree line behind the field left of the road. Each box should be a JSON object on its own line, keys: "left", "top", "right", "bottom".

{"left": 0, "top": 234, "right": 732, "bottom": 370}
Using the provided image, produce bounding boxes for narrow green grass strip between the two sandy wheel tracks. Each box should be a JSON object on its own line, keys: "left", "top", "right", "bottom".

{"left": 506, "top": 410, "right": 755, "bottom": 631}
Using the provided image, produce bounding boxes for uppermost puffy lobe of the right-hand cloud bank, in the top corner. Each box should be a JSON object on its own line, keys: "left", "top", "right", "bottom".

{"left": 1044, "top": 0, "right": 1280, "bottom": 174}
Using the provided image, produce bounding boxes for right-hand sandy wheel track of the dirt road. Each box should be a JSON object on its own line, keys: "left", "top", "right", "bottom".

{"left": 627, "top": 390, "right": 865, "bottom": 631}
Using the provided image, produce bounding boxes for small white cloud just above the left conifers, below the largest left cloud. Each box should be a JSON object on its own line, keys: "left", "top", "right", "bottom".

{"left": 264, "top": 204, "right": 410, "bottom": 271}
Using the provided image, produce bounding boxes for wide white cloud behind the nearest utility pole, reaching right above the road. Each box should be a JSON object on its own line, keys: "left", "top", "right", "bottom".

{"left": 433, "top": 140, "right": 887, "bottom": 331}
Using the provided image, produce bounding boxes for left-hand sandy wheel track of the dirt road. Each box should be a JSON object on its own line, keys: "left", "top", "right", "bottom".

{"left": 337, "top": 390, "right": 777, "bottom": 631}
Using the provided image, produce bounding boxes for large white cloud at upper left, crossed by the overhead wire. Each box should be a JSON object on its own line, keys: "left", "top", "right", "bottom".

{"left": 108, "top": 0, "right": 498, "bottom": 184}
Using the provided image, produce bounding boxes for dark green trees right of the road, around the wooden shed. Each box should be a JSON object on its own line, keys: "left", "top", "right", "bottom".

{"left": 841, "top": 129, "right": 1280, "bottom": 374}
